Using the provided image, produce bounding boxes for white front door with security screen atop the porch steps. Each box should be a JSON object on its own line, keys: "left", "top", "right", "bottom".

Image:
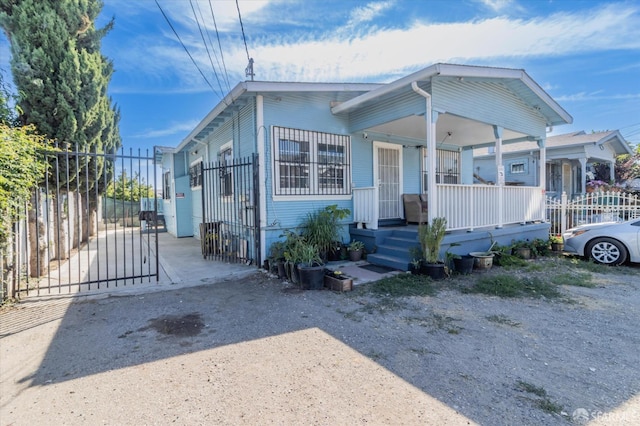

{"left": 373, "top": 142, "right": 402, "bottom": 219}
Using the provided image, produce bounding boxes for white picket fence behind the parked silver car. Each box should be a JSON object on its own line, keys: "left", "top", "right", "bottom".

{"left": 547, "top": 192, "right": 640, "bottom": 235}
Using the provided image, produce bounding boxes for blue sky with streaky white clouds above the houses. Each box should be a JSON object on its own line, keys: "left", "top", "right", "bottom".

{"left": 0, "top": 0, "right": 640, "bottom": 150}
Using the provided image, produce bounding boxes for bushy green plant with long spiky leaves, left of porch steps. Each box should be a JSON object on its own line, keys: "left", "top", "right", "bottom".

{"left": 302, "top": 204, "right": 351, "bottom": 260}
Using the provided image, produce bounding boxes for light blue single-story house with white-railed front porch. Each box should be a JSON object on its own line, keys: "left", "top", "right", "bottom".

{"left": 157, "top": 64, "right": 572, "bottom": 269}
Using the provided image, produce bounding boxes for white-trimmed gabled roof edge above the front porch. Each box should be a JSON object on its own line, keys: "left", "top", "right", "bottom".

{"left": 331, "top": 64, "right": 573, "bottom": 126}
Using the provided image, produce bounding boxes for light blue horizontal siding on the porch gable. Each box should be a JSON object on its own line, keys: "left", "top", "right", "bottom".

{"left": 433, "top": 79, "right": 546, "bottom": 137}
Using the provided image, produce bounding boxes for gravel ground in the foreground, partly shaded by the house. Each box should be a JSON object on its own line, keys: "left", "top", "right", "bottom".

{"left": 0, "top": 258, "right": 640, "bottom": 425}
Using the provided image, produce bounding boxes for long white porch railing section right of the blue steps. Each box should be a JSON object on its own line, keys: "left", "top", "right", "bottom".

{"left": 436, "top": 184, "right": 545, "bottom": 230}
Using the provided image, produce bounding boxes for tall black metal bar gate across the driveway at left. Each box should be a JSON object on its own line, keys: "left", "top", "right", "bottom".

{"left": 9, "top": 145, "right": 163, "bottom": 297}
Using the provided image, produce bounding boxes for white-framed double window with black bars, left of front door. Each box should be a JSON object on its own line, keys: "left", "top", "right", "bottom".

{"left": 272, "top": 126, "right": 351, "bottom": 196}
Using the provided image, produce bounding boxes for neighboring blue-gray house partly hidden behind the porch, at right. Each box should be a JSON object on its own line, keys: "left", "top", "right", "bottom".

{"left": 474, "top": 130, "right": 633, "bottom": 197}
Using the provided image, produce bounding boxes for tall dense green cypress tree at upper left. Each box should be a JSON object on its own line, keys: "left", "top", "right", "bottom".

{"left": 0, "top": 0, "right": 121, "bottom": 189}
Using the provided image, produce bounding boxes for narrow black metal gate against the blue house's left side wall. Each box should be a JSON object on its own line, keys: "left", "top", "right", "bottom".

{"left": 200, "top": 154, "right": 260, "bottom": 265}
